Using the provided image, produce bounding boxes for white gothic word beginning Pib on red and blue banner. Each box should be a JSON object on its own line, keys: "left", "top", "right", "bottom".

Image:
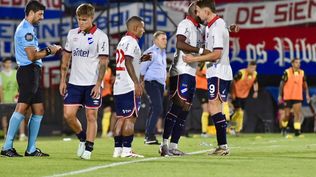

{"left": 273, "top": 37, "right": 316, "bottom": 66}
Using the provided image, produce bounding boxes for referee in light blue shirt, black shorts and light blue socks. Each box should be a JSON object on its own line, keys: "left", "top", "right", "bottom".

{"left": 1, "top": 0, "right": 61, "bottom": 157}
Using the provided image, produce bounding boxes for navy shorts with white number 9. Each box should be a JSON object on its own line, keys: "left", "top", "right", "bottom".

{"left": 207, "top": 77, "right": 230, "bottom": 102}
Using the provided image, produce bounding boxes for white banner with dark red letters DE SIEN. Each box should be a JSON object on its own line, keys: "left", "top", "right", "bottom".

{"left": 219, "top": 0, "right": 316, "bottom": 28}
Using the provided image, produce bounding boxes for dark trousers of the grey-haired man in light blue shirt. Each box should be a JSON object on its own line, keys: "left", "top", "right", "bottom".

{"left": 145, "top": 81, "right": 164, "bottom": 136}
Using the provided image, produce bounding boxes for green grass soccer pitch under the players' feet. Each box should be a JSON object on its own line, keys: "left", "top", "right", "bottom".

{"left": 0, "top": 134, "right": 316, "bottom": 177}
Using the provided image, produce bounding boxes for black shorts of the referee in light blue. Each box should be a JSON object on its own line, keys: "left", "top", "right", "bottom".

{"left": 16, "top": 64, "right": 43, "bottom": 104}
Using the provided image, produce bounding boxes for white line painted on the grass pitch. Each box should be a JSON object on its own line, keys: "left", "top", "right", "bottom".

{"left": 45, "top": 149, "right": 210, "bottom": 177}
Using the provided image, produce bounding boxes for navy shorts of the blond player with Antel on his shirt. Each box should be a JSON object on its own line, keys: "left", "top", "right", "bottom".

{"left": 64, "top": 84, "right": 102, "bottom": 109}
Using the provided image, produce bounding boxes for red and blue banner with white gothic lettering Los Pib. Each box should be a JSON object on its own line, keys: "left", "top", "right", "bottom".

{"left": 230, "top": 26, "right": 316, "bottom": 75}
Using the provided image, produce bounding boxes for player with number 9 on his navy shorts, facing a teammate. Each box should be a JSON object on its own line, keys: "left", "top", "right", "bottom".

{"left": 183, "top": 0, "right": 233, "bottom": 155}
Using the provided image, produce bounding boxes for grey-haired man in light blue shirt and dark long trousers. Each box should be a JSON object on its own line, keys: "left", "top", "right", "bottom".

{"left": 140, "top": 31, "right": 167, "bottom": 144}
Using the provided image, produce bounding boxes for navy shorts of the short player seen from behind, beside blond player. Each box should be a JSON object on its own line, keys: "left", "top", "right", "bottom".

{"left": 114, "top": 91, "right": 140, "bottom": 118}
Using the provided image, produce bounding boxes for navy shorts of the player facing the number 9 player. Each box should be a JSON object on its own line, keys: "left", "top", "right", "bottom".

{"left": 169, "top": 74, "right": 196, "bottom": 104}
